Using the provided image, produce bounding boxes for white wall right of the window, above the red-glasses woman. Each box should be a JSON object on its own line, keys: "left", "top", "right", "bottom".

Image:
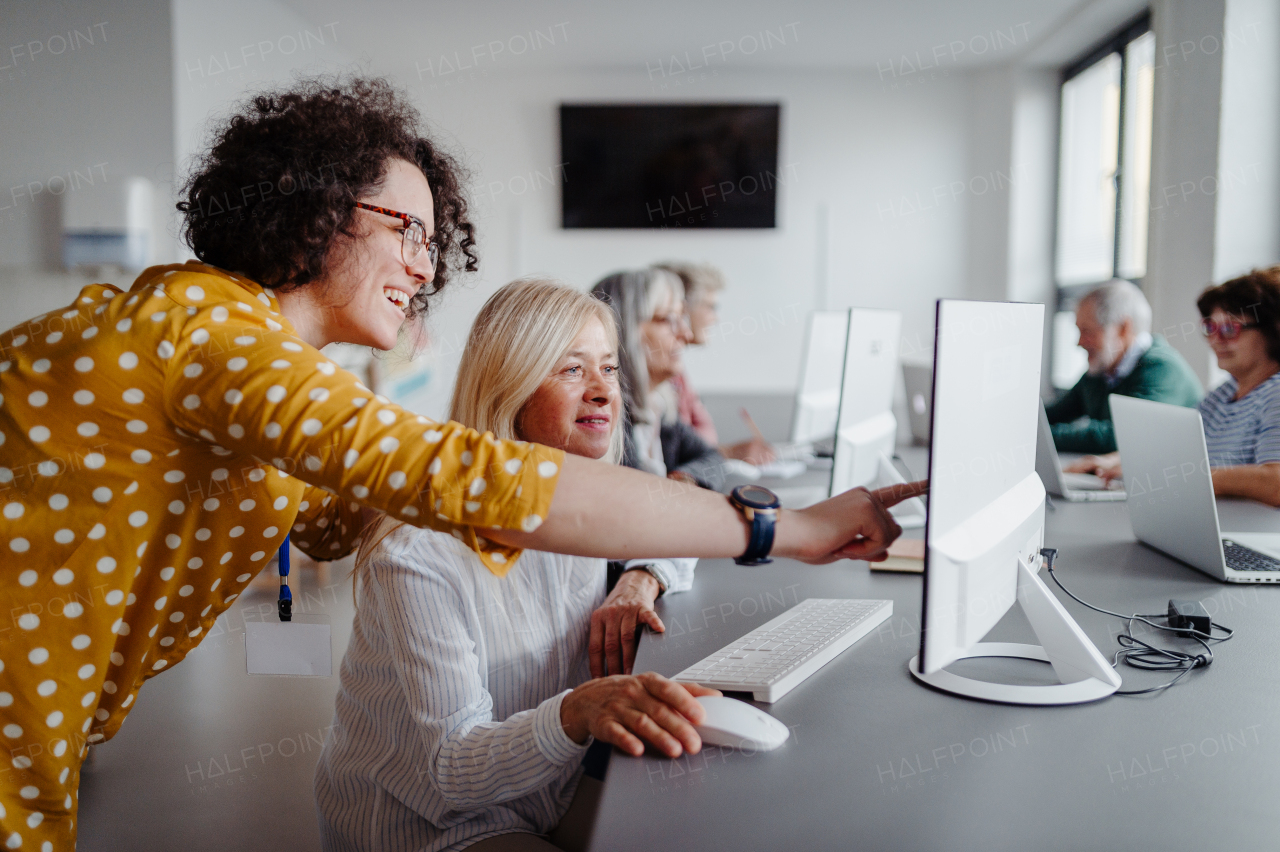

{"left": 1146, "top": 0, "right": 1280, "bottom": 385}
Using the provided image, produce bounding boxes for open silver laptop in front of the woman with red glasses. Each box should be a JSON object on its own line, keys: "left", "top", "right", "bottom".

{"left": 1110, "top": 394, "right": 1280, "bottom": 583}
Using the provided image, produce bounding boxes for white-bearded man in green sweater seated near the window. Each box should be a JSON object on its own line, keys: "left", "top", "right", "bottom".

{"left": 1046, "top": 279, "right": 1202, "bottom": 453}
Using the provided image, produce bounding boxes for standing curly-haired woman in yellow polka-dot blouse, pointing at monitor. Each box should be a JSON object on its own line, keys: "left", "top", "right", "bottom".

{"left": 0, "top": 79, "right": 921, "bottom": 849}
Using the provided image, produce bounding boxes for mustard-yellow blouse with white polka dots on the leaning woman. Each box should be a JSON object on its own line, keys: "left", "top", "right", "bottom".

{"left": 0, "top": 262, "right": 563, "bottom": 849}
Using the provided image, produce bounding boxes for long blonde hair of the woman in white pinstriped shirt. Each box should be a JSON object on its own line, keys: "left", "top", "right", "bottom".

{"left": 355, "top": 278, "right": 625, "bottom": 576}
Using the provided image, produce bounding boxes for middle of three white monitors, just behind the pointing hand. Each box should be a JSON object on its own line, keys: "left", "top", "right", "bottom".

{"left": 829, "top": 308, "right": 924, "bottom": 527}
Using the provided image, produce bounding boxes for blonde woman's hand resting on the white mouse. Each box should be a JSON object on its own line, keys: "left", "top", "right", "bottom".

{"left": 561, "top": 672, "right": 721, "bottom": 757}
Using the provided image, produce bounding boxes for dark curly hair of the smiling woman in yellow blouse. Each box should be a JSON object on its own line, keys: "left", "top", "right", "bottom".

{"left": 178, "top": 78, "right": 479, "bottom": 319}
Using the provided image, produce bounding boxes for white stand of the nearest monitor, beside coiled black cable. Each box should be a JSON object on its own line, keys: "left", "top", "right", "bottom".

{"left": 908, "top": 559, "right": 1120, "bottom": 705}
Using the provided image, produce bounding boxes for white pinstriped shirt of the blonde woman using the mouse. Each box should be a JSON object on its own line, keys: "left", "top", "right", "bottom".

{"left": 315, "top": 526, "right": 695, "bottom": 852}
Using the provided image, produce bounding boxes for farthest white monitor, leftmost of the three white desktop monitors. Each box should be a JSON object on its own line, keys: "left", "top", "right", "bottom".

{"left": 791, "top": 311, "right": 849, "bottom": 444}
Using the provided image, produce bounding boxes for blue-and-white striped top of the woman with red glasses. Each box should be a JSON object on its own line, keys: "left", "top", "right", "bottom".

{"left": 1199, "top": 372, "right": 1280, "bottom": 467}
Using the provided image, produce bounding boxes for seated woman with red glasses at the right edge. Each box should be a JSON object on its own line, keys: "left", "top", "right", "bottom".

{"left": 1070, "top": 266, "right": 1280, "bottom": 507}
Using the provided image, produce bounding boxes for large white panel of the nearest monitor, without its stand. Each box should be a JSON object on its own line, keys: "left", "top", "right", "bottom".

{"left": 922, "top": 299, "right": 1044, "bottom": 672}
